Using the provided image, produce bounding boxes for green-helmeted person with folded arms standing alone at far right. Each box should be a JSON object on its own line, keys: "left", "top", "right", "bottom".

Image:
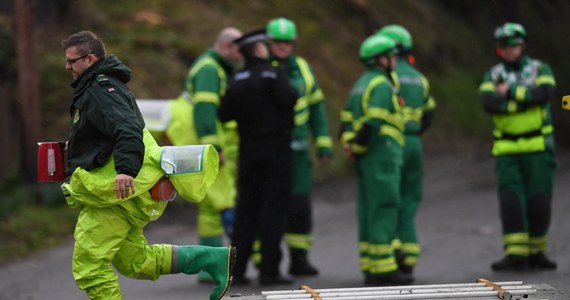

{"left": 479, "top": 23, "right": 556, "bottom": 271}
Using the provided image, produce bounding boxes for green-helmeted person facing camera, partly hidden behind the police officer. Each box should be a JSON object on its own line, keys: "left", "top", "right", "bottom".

{"left": 254, "top": 18, "right": 332, "bottom": 276}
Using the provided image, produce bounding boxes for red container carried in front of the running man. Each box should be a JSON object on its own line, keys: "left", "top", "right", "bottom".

{"left": 38, "top": 142, "right": 65, "bottom": 182}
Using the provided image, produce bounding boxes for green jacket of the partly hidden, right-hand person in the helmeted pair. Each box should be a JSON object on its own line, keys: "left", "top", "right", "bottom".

{"left": 395, "top": 57, "right": 435, "bottom": 134}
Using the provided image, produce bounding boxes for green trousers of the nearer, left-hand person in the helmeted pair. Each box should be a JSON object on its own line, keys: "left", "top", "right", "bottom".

{"left": 355, "top": 139, "right": 402, "bottom": 276}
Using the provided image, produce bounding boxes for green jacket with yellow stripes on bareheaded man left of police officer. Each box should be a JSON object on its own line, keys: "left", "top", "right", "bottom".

{"left": 186, "top": 49, "right": 235, "bottom": 154}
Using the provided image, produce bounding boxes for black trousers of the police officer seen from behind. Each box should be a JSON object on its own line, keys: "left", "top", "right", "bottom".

{"left": 232, "top": 149, "right": 293, "bottom": 277}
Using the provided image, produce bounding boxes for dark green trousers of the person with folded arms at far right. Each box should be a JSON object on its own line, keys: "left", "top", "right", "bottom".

{"left": 495, "top": 151, "right": 556, "bottom": 256}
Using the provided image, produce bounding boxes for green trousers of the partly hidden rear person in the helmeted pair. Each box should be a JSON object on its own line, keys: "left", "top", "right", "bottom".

{"left": 396, "top": 135, "right": 423, "bottom": 267}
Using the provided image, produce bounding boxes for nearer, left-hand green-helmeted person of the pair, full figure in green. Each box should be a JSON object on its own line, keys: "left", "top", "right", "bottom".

{"left": 340, "top": 34, "right": 412, "bottom": 286}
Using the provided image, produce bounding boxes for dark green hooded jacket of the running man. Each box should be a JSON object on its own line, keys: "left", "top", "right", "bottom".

{"left": 67, "top": 55, "right": 145, "bottom": 177}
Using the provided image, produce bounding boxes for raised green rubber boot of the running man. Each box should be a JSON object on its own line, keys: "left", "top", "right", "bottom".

{"left": 173, "top": 246, "right": 236, "bottom": 300}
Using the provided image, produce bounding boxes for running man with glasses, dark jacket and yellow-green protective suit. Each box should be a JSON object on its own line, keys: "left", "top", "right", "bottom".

{"left": 62, "top": 31, "right": 236, "bottom": 300}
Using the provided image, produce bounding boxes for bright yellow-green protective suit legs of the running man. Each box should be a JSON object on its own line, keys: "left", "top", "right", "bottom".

{"left": 72, "top": 205, "right": 172, "bottom": 300}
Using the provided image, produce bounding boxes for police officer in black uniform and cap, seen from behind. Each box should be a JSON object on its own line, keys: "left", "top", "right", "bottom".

{"left": 218, "top": 30, "right": 297, "bottom": 285}
